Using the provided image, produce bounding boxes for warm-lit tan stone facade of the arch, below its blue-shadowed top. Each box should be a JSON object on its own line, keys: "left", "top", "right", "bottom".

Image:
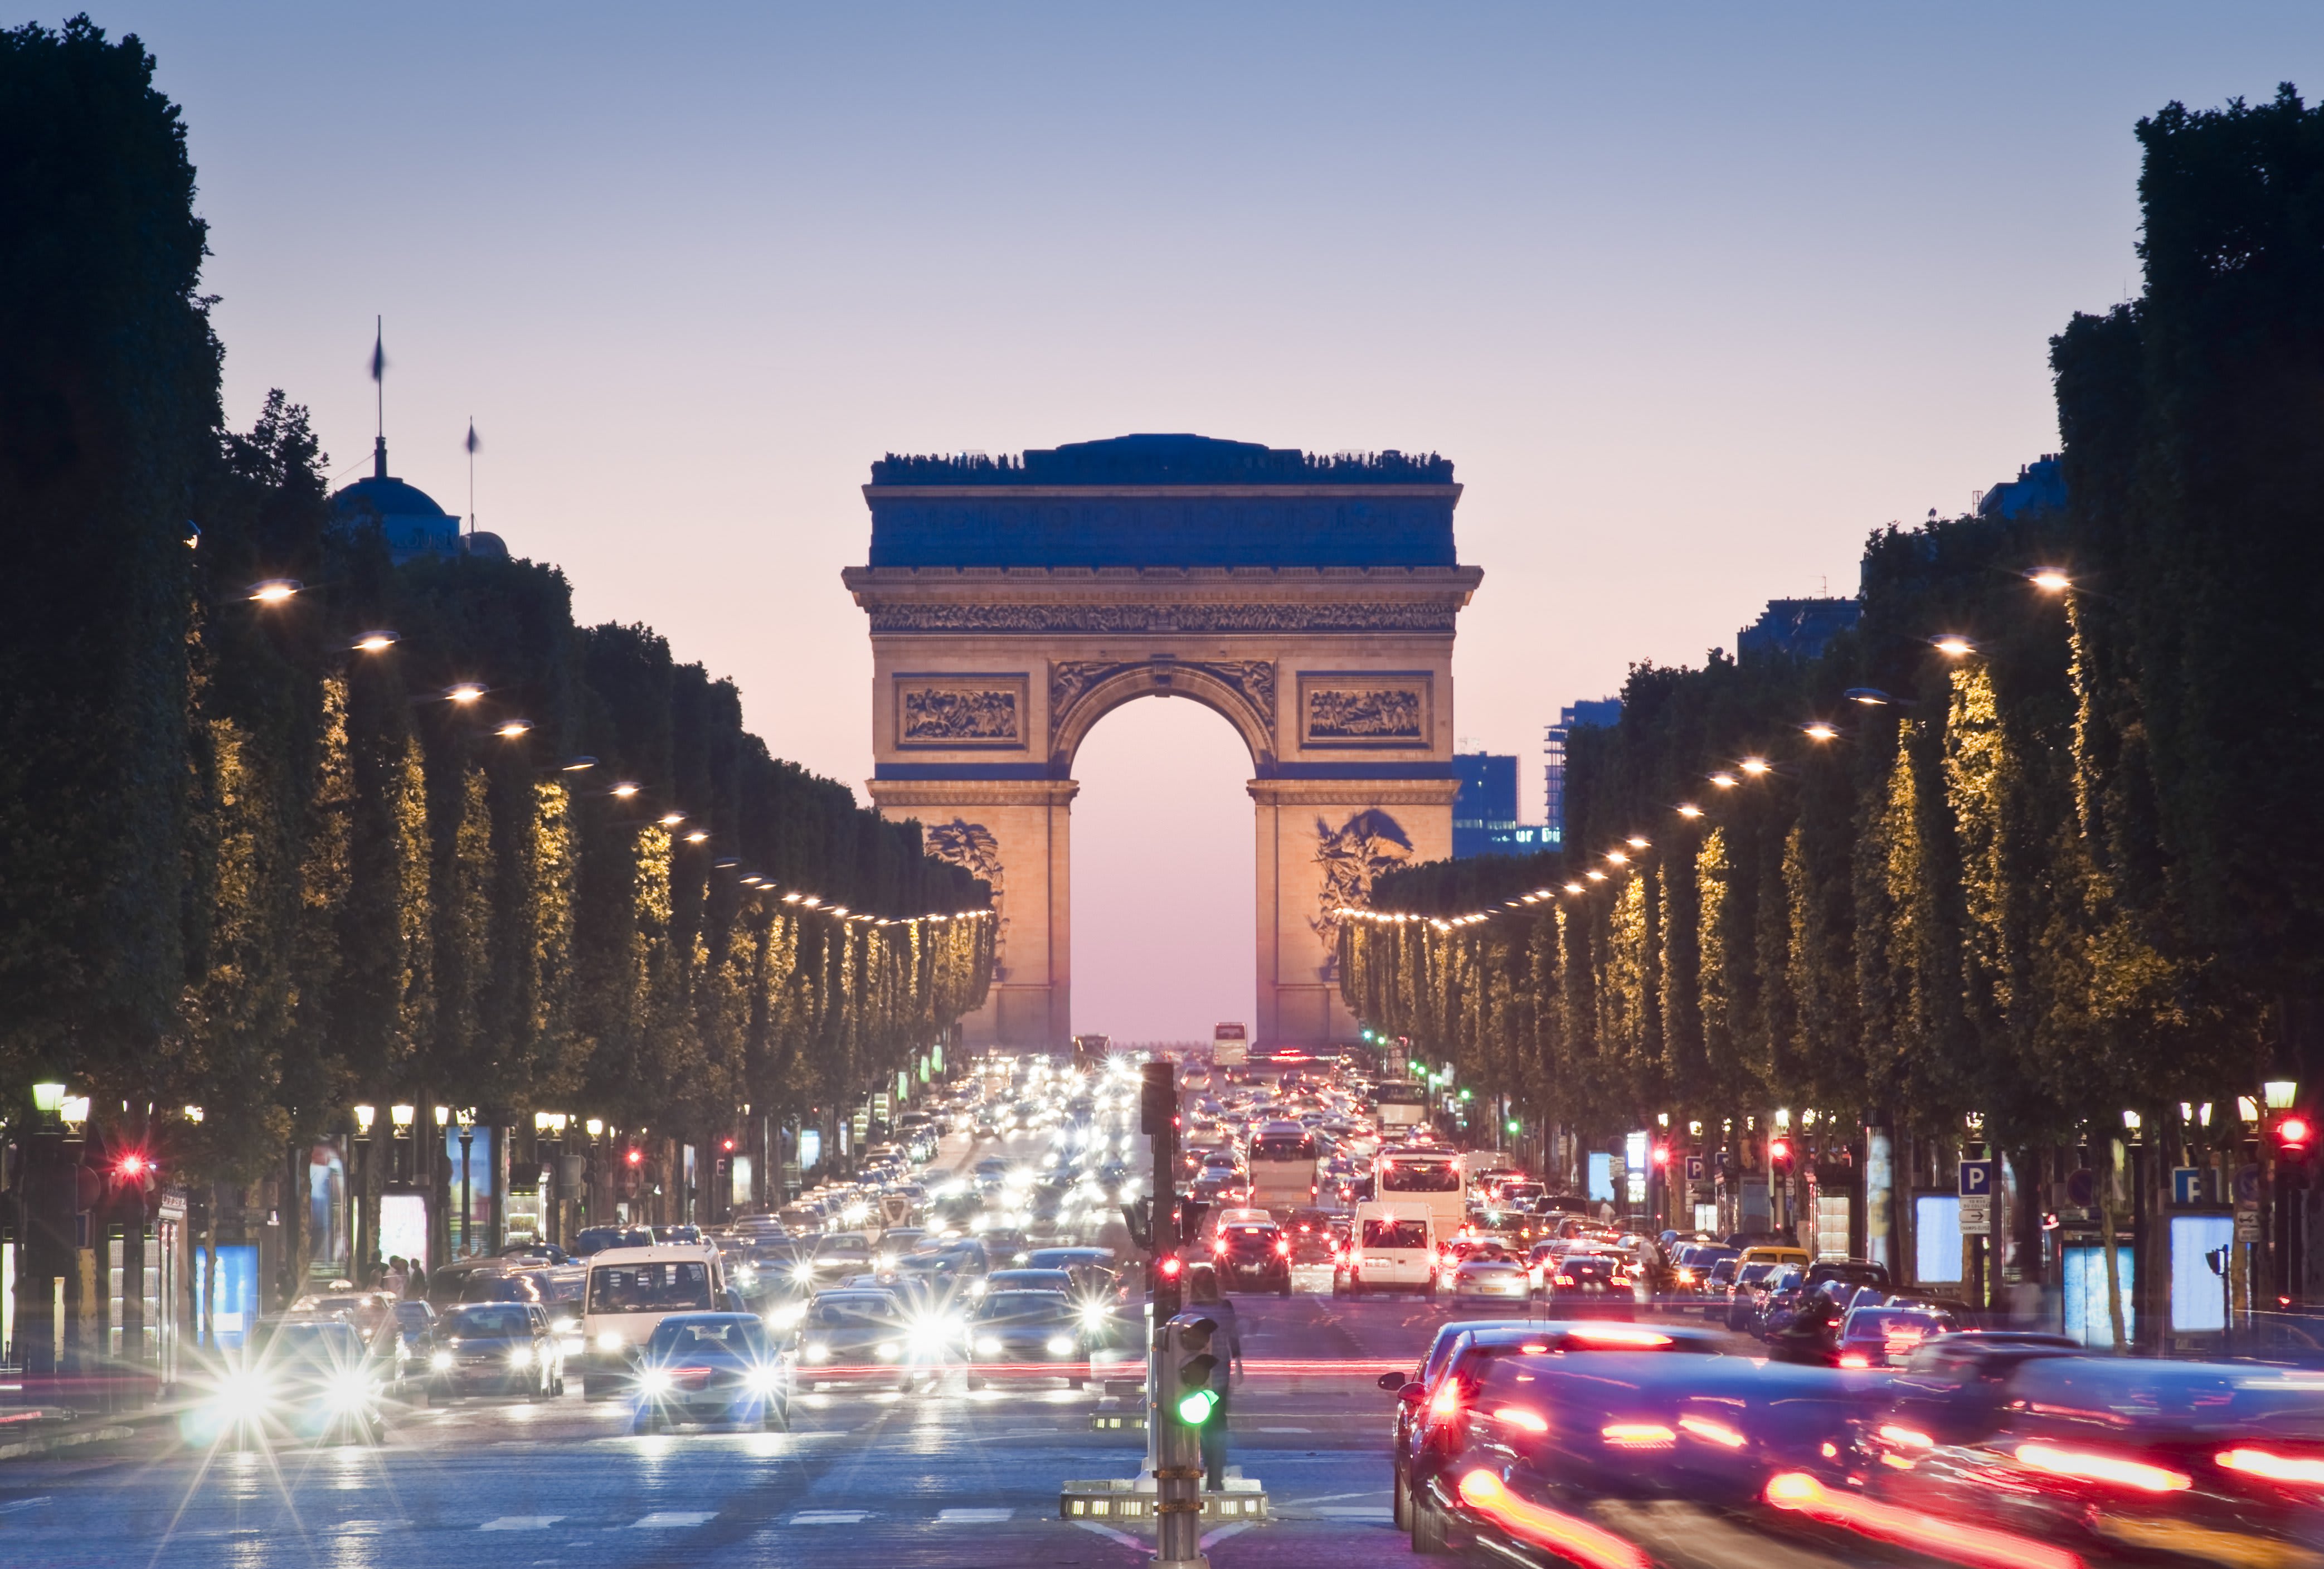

{"left": 844, "top": 441, "right": 1482, "bottom": 1048}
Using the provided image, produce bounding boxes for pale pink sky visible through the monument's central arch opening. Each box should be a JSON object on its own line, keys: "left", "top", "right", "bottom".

{"left": 1071, "top": 702, "right": 1255, "bottom": 1041}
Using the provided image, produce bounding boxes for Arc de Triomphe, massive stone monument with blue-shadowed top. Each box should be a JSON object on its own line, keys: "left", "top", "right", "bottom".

{"left": 844, "top": 435, "right": 1482, "bottom": 1048}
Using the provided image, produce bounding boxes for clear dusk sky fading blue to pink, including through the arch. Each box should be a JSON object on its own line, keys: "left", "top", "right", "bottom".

{"left": 104, "top": 0, "right": 2324, "bottom": 1039}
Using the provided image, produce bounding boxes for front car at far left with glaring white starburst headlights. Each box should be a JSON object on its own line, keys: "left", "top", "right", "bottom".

{"left": 179, "top": 1315, "right": 386, "bottom": 1448}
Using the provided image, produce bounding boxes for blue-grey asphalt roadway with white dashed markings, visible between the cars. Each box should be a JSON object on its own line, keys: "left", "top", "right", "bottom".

{"left": 0, "top": 1125, "right": 1831, "bottom": 1569}
